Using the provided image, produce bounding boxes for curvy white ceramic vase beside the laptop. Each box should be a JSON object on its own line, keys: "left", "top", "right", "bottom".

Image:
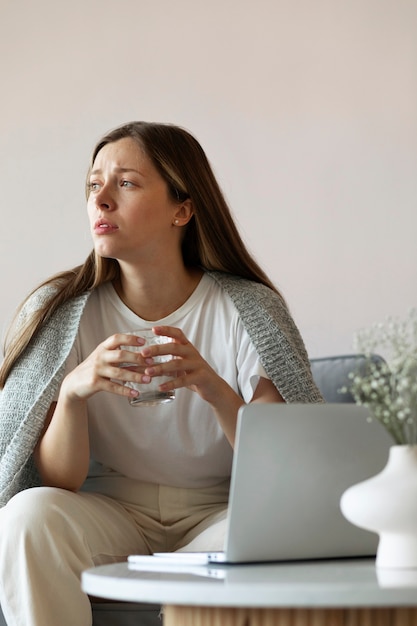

{"left": 340, "top": 445, "right": 417, "bottom": 568}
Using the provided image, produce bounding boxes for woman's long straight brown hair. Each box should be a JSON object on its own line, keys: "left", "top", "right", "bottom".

{"left": 0, "top": 122, "right": 277, "bottom": 388}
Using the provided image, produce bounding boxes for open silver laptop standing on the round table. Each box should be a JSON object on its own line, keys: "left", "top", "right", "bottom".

{"left": 129, "top": 403, "right": 393, "bottom": 567}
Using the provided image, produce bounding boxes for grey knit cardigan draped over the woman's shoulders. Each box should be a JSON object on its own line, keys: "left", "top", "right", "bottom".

{"left": 0, "top": 272, "right": 323, "bottom": 506}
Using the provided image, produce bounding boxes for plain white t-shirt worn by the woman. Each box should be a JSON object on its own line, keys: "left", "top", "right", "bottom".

{"left": 62, "top": 274, "right": 267, "bottom": 488}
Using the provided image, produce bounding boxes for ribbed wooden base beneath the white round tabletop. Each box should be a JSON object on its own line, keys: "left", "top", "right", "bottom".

{"left": 164, "top": 606, "right": 417, "bottom": 626}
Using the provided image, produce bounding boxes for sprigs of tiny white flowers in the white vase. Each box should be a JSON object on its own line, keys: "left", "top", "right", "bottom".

{"left": 344, "top": 309, "right": 417, "bottom": 445}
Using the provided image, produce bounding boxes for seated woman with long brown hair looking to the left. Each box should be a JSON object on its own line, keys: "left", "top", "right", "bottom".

{"left": 0, "top": 122, "right": 322, "bottom": 626}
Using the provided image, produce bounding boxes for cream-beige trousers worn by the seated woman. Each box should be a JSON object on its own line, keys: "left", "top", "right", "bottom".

{"left": 0, "top": 477, "right": 229, "bottom": 626}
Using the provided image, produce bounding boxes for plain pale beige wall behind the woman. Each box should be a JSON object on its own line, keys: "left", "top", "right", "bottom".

{"left": 0, "top": 0, "right": 417, "bottom": 356}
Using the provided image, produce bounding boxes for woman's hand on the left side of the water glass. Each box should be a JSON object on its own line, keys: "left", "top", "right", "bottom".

{"left": 61, "top": 333, "right": 150, "bottom": 401}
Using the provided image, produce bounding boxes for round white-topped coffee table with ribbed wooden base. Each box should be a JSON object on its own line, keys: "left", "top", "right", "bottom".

{"left": 82, "top": 559, "right": 417, "bottom": 626}
